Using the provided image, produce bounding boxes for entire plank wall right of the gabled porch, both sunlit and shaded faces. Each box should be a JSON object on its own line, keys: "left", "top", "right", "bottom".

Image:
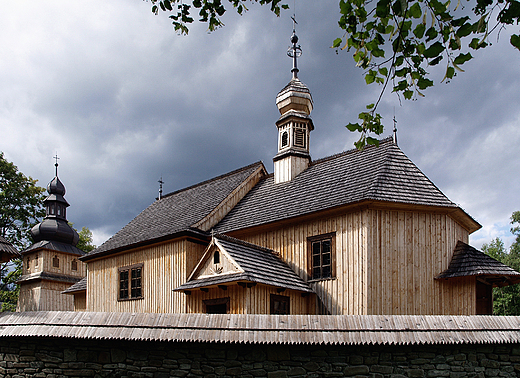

{"left": 232, "top": 209, "right": 475, "bottom": 315}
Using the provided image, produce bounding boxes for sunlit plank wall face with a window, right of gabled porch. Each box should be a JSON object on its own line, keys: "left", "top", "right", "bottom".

{"left": 232, "top": 212, "right": 367, "bottom": 315}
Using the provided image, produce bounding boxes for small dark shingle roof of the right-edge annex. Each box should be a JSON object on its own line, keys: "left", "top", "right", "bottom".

{"left": 435, "top": 241, "right": 520, "bottom": 286}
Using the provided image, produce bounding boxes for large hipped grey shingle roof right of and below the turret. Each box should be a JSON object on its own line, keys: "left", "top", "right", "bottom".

{"left": 215, "top": 138, "right": 469, "bottom": 233}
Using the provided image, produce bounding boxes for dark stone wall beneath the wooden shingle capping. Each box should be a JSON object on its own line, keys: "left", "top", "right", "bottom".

{"left": 0, "top": 338, "right": 520, "bottom": 378}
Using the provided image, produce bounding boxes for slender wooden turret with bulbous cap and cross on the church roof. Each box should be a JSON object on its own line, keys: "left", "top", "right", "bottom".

{"left": 273, "top": 24, "right": 314, "bottom": 183}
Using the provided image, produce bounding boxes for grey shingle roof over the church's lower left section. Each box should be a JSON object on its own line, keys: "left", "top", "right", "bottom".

{"left": 84, "top": 162, "right": 263, "bottom": 259}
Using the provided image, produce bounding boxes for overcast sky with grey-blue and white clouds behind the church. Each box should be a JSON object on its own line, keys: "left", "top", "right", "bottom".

{"left": 0, "top": 0, "right": 520, "bottom": 248}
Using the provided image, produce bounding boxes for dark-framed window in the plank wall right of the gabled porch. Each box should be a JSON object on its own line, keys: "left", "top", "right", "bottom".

{"left": 307, "top": 232, "right": 336, "bottom": 280}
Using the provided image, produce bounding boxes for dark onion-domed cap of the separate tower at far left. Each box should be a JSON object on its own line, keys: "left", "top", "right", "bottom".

{"left": 31, "top": 164, "right": 79, "bottom": 246}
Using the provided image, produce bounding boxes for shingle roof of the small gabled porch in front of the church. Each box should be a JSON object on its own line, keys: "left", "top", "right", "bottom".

{"left": 175, "top": 235, "right": 312, "bottom": 293}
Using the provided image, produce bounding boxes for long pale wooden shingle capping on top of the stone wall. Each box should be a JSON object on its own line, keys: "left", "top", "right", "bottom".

{"left": 0, "top": 311, "right": 520, "bottom": 345}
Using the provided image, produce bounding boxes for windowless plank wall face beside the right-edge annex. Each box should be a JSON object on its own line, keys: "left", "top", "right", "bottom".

{"left": 367, "top": 210, "right": 476, "bottom": 315}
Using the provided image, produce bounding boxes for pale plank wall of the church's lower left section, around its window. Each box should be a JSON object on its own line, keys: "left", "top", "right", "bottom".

{"left": 87, "top": 239, "right": 205, "bottom": 312}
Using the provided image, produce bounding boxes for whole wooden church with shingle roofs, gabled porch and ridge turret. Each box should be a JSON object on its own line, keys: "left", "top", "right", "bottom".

{"left": 16, "top": 29, "right": 520, "bottom": 315}
